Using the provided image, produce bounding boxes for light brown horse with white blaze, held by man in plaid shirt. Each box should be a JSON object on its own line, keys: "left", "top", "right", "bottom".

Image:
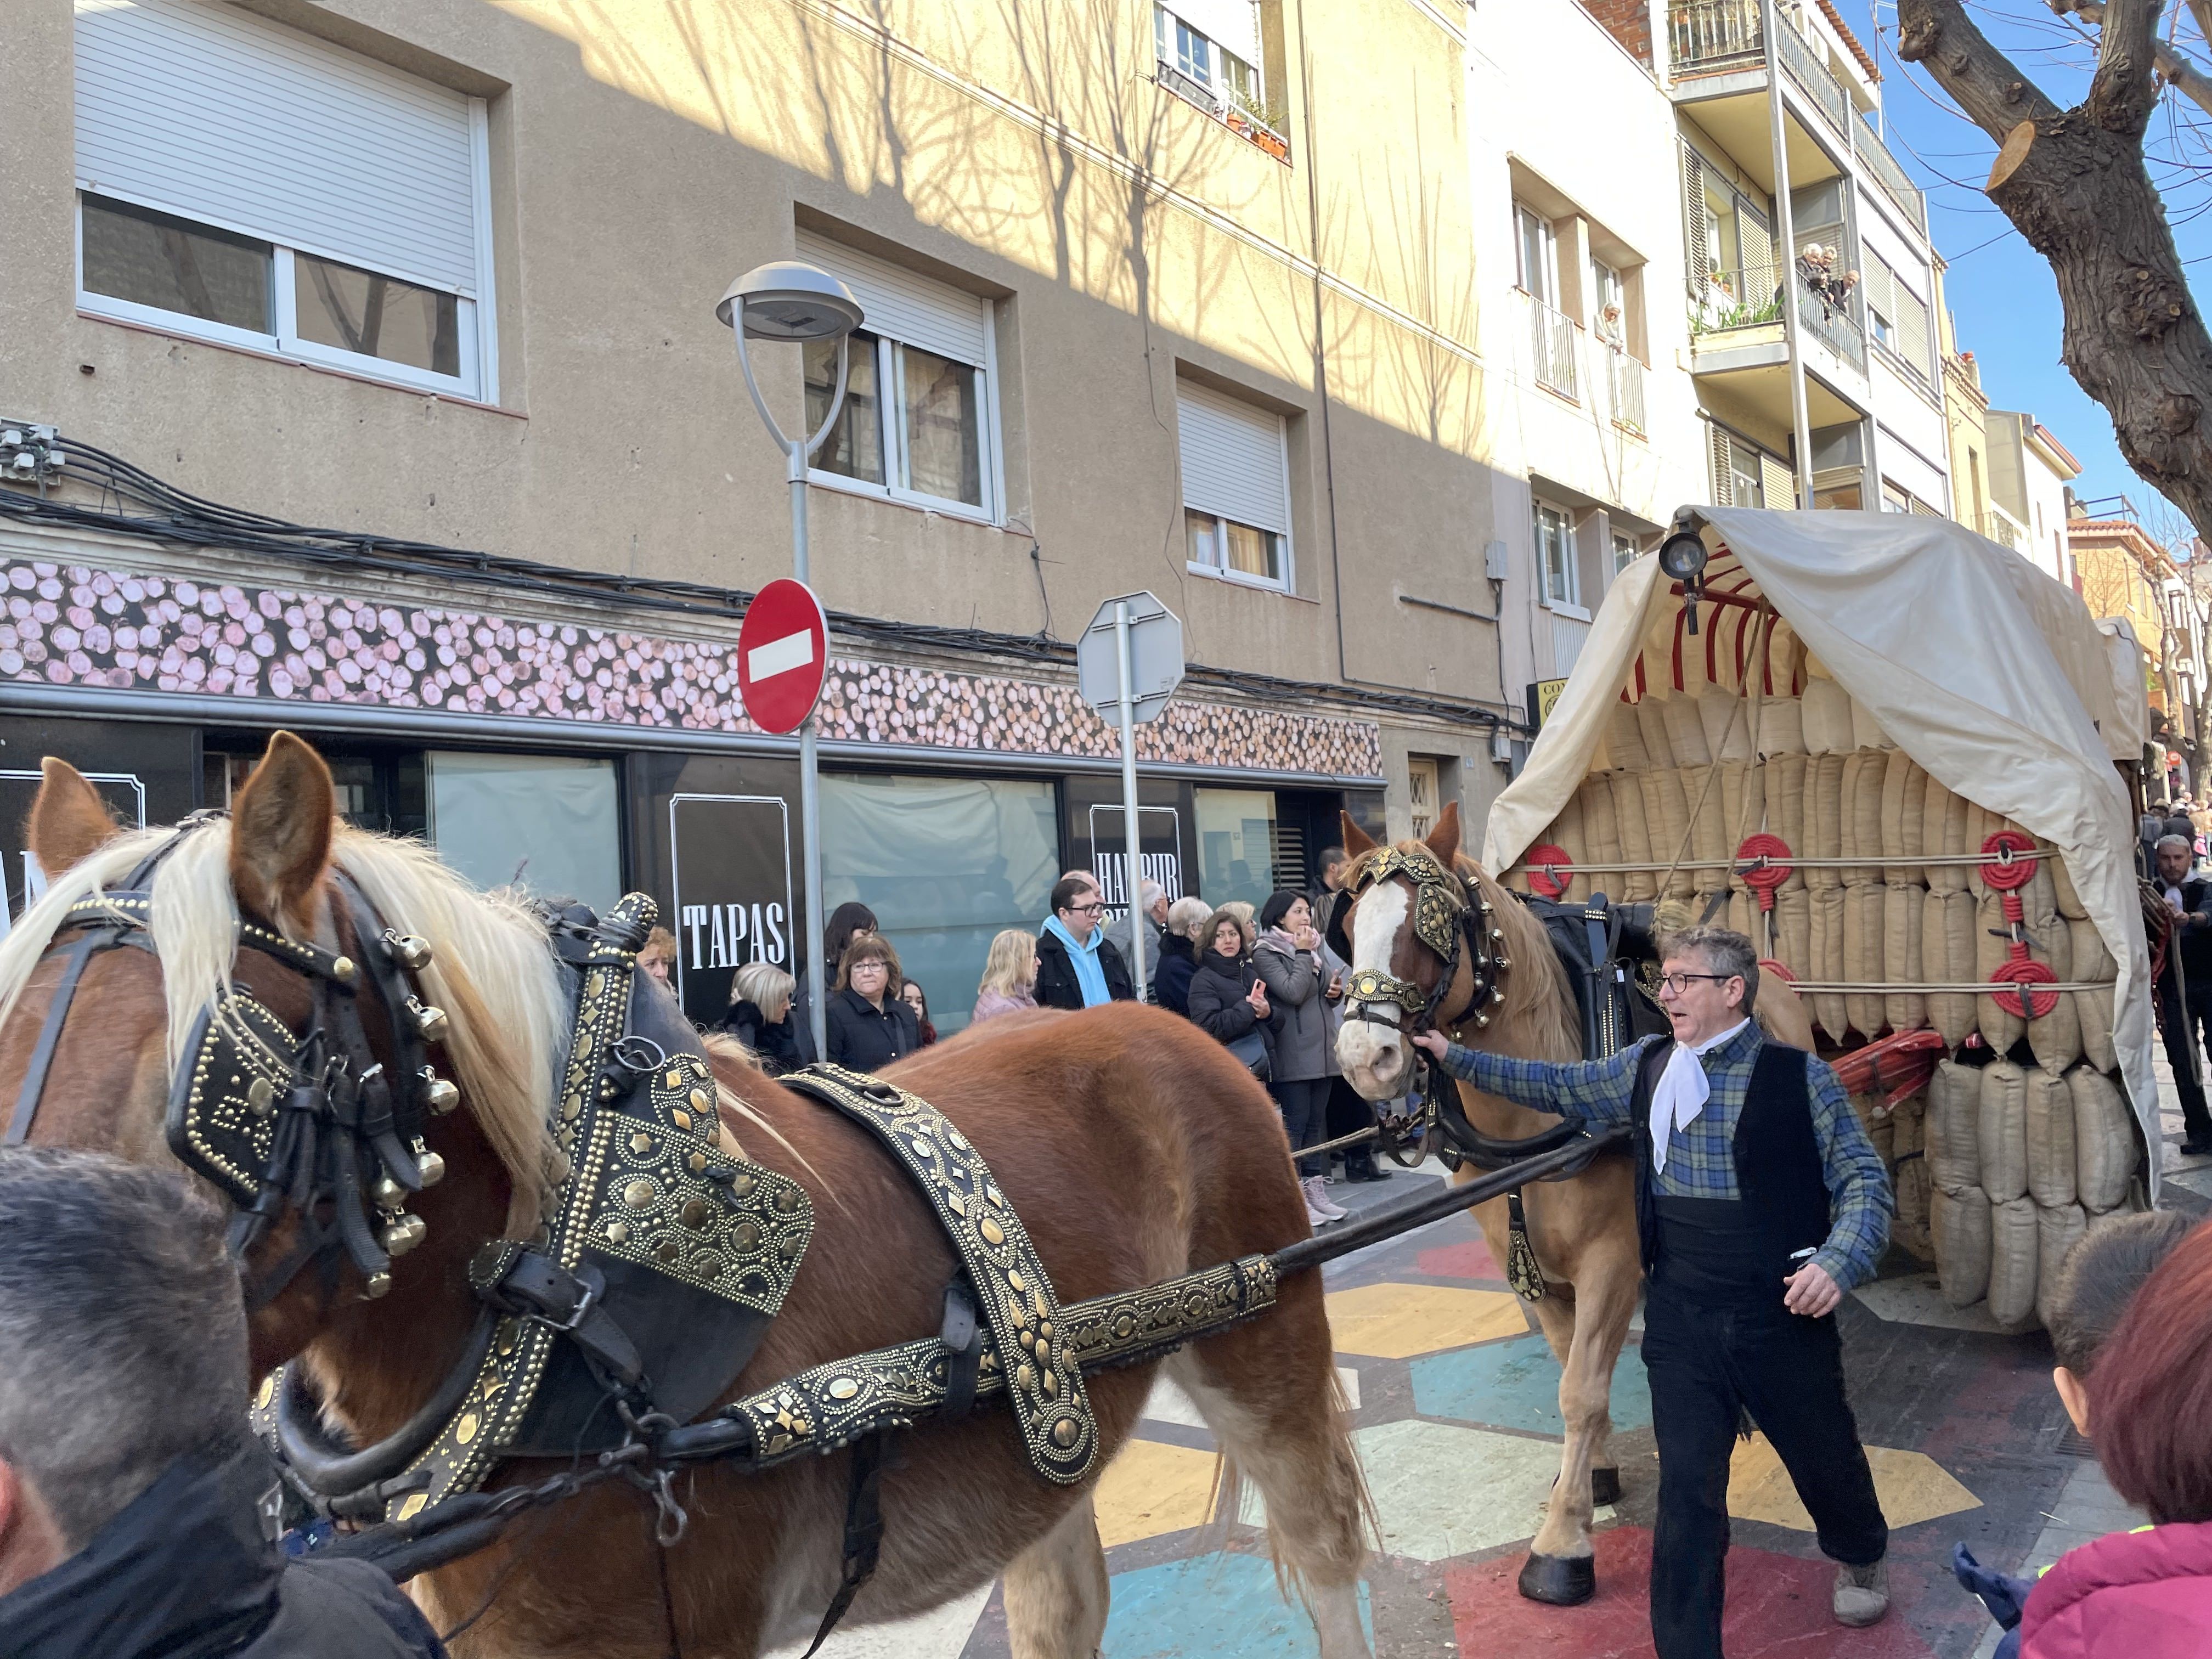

{"left": 1336, "top": 803, "right": 1812, "bottom": 1606}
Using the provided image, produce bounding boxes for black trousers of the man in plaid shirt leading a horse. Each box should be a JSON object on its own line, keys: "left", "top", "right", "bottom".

{"left": 1644, "top": 1269, "right": 1889, "bottom": 1659}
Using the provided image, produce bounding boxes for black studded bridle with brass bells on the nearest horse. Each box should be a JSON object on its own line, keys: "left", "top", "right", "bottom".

{"left": 0, "top": 812, "right": 460, "bottom": 1307}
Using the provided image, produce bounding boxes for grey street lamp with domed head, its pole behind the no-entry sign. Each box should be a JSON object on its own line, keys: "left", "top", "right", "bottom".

{"left": 714, "top": 261, "right": 867, "bottom": 1059}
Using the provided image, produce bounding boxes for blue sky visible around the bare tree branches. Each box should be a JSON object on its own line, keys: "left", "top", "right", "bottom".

{"left": 1836, "top": 0, "right": 2212, "bottom": 526}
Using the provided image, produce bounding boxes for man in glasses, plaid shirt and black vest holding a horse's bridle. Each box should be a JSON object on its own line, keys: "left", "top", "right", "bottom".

{"left": 1413, "top": 927, "right": 1893, "bottom": 1659}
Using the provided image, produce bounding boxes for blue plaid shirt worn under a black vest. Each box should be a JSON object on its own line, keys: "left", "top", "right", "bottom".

{"left": 1444, "top": 1022, "right": 1895, "bottom": 1290}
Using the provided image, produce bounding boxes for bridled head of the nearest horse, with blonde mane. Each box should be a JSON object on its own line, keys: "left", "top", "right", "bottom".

{"left": 0, "top": 732, "right": 564, "bottom": 1389}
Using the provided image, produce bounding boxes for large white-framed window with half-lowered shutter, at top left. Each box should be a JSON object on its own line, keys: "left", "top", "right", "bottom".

{"left": 75, "top": 0, "right": 498, "bottom": 400}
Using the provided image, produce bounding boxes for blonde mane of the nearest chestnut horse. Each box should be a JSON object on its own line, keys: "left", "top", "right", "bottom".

{"left": 0, "top": 819, "right": 568, "bottom": 1237}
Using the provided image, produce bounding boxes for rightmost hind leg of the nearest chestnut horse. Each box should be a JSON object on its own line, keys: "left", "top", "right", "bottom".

{"left": 1166, "top": 1300, "right": 1369, "bottom": 1659}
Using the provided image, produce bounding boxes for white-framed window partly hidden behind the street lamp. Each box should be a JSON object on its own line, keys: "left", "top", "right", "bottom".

{"left": 799, "top": 230, "right": 1002, "bottom": 522}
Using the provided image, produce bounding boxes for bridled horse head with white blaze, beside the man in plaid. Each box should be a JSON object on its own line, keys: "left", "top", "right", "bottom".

{"left": 1329, "top": 803, "right": 1573, "bottom": 1099}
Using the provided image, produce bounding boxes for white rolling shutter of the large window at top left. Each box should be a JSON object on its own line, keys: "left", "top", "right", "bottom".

{"left": 75, "top": 0, "right": 478, "bottom": 296}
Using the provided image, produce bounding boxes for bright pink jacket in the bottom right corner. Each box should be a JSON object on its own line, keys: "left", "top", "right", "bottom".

{"left": 2019, "top": 1522, "right": 2212, "bottom": 1659}
